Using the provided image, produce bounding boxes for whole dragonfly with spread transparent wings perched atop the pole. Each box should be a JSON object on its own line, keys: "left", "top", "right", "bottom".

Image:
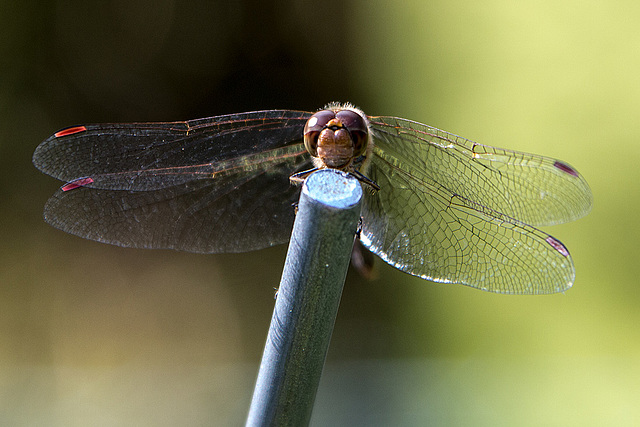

{"left": 33, "top": 103, "right": 592, "bottom": 294}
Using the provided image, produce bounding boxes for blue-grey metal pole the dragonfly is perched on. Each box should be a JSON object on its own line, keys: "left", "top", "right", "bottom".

{"left": 246, "top": 169, "right": 362, "bottom": 426}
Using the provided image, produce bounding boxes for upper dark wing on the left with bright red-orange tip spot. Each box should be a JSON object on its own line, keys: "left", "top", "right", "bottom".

{"left": 33, "top": 110, "right": 311, "bottom": 185}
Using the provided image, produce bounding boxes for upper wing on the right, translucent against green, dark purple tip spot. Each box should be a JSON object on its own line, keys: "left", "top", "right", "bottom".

{"left": 371, "top": 117, "right": 592, "bottom": 226}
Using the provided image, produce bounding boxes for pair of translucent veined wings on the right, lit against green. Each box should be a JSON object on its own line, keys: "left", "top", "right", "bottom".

{"left": 361, "top": 117, "right": 591, "bottom": 294}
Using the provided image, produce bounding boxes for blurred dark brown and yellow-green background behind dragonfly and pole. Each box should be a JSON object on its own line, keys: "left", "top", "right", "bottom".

{"left": 0, "top": 0, "right": 640, "bottom": 426}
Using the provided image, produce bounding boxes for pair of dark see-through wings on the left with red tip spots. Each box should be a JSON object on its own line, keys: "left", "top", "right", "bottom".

{"left": 34, "top": 111, "right": 311, "bottom": 253}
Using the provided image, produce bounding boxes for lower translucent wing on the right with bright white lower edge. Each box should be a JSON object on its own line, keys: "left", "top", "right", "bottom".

{"left": 360, "top": 159, "right": 575, "bottom": 294}
